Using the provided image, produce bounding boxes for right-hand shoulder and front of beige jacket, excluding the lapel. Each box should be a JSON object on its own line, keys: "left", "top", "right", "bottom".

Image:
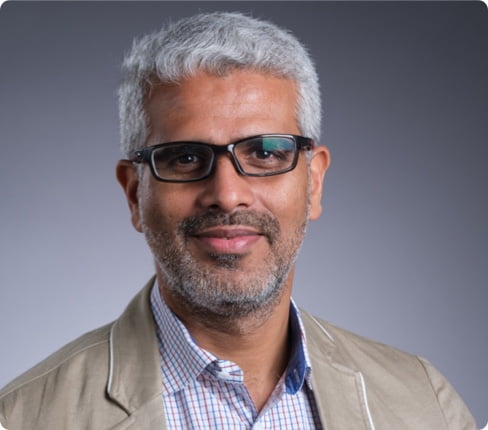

{"left": 303, "top": 313, "right": 476, "bottom": 430}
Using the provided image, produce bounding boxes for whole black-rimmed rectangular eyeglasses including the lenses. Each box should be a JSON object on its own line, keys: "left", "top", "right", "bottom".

{"left": 131, "top": 134, "right": 315, "bottom": 182}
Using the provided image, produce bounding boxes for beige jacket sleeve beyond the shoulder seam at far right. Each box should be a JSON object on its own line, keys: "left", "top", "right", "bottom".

{"left": 419, "top": 357, "right": 478, "bottom": 430}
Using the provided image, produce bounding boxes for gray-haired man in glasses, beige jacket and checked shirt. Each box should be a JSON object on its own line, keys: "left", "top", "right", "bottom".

{"left": 0, "top": 13, "right": 475, "bottom": 430}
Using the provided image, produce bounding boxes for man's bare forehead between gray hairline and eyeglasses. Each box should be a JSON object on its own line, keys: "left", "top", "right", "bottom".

{"left": 146, "top": 70, "right": 298, "bottom": 142}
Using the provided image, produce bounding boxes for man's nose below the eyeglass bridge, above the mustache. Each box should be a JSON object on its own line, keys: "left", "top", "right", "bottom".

{"left": 194, "top": 154, "right": 254, "bottom": 213}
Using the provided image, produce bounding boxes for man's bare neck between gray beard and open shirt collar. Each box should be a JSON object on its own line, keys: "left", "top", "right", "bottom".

{"left": 158, "top": 276, "right": 292, "bottom": 410}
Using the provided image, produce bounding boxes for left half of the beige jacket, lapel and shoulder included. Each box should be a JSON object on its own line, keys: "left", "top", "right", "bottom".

{"left": 0, "top": 281, "right": 158, "bottom": 430}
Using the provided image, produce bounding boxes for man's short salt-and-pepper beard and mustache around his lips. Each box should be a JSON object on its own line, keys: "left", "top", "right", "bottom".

{"left": 143, "top": 211, "right": 308, "bottom": 321}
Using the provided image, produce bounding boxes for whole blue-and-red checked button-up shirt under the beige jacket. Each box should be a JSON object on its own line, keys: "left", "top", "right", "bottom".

{"left": 151, "top": 283, "right": 322, "bottom": 430}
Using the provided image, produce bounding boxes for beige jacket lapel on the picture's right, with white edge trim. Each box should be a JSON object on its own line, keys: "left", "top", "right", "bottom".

{"left": 301, "top": 311, "right": 371, "bottom": 430}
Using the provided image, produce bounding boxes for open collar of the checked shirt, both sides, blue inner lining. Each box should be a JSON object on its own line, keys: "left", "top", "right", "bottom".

{"left": 150, "top": 282, "right": 311, "bottom": 394}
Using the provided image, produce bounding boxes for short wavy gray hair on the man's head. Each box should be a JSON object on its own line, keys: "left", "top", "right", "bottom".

{"left": 118, "top": 12, "right": 321, "bottom": 156}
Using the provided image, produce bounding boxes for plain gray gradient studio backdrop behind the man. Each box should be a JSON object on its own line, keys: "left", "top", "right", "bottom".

{"left": 0, "top": 2, "right": 488, "bottom": 426}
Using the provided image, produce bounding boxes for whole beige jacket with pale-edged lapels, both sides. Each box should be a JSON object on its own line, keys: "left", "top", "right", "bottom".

{"left": 0, "top": 283, "right": 476, "bottom": 430}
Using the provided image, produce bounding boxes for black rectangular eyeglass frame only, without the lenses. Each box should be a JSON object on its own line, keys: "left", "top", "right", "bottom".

{"left": 129, "top": 134, "right": 315, "bottom": 183}
